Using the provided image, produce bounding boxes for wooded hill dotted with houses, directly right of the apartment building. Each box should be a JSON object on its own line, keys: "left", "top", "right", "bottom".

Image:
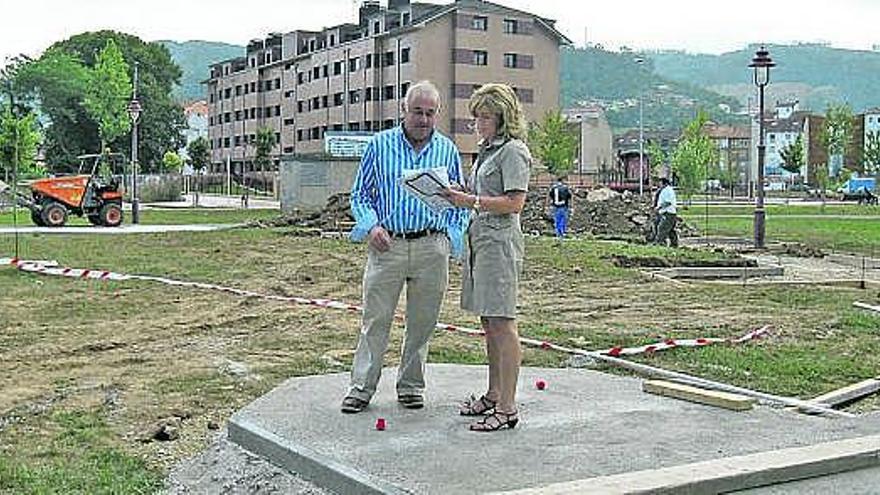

{"left": 560, "top": 47, "right": 745, "bottom": 130}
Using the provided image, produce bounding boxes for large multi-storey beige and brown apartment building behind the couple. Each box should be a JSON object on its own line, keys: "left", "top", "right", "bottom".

{"left": 206, "top": 0, "right": 570, "bottom": 172}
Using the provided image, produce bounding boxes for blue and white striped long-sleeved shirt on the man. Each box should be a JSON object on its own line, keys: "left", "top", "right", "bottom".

{"left": 351, "top": 126, "right": 467, "bottom": 257}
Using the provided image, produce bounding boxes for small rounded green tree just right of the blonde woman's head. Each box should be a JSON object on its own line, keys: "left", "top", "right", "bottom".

{"left": 529, "top": 110, "right": 578, "bottom": 177}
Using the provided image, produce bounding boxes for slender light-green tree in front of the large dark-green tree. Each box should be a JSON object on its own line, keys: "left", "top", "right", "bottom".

{"left": 83, "top": 38, "right": 132, "bottom": 152}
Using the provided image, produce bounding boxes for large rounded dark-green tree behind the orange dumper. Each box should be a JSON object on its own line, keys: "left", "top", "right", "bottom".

{"left": 17, "top": 31, "right": 185, "bottom": 172}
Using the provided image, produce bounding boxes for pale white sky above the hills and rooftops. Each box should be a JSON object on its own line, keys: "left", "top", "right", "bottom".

{"left": 0, "top": 0, "right": 880, "bottom": 65}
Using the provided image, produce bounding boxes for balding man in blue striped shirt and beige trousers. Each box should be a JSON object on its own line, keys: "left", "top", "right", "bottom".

{"left": 342, "top": 81, "right": 467, "bottom": 413}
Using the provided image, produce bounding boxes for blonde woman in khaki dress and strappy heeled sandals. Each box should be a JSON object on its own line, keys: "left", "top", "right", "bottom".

{"left": 447, "top": 84, "right": 531, "bottom": 431}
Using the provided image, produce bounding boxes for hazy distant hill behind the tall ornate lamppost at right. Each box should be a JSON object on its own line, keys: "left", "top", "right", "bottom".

{"left": 646, "top": 44, "right": 880, "bottom": 113}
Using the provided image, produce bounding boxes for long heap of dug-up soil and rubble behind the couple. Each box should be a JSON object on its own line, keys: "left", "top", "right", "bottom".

{"left": 252, "top": 187, "right": 693, "bottom": 239}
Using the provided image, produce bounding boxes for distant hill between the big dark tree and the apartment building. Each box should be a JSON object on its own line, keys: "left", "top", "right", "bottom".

{"left": 159, "top": 41, "right": 245, "bottom": 101}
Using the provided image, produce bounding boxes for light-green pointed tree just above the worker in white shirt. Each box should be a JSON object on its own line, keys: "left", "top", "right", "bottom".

{"left": 671, "top": 110, "right": 718, "bottom": 200}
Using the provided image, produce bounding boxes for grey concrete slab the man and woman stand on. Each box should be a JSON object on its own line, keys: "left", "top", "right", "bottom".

{"left": 229, "top": 364, "right": 880, "bottom": 494}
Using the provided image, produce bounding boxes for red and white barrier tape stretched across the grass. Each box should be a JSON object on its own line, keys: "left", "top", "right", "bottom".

{"left": 0, "top": 258, "right": 769, "bottom": 357}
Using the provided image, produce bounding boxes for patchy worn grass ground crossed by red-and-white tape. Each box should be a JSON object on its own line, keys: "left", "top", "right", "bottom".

{"left": 0, "top": 219, "right": 880, "bottom": 494}
